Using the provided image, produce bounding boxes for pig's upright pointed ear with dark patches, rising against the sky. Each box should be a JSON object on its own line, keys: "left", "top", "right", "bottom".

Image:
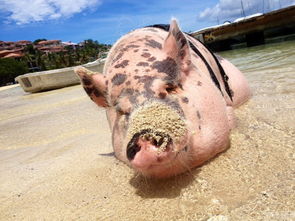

{"left": 164, "top": 19, "right": 191, "bottom": 71}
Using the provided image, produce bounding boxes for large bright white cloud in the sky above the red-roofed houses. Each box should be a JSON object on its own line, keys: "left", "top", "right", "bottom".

{"left": 0, "top": 0, "right": 101, "bottom": 24}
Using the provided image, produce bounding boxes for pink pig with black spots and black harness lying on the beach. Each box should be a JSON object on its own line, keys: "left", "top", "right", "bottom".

{"left": 75, "top": 19, "right": 251, "bottom": 178}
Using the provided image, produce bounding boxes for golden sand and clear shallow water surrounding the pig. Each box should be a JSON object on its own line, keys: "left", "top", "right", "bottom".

{"left": 0, "top": 41, "right": 295, "bottom": 221}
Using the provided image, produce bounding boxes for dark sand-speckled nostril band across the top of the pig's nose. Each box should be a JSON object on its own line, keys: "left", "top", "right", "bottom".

{"left": 126, "top": 129, "right": 173, "bottom": 161}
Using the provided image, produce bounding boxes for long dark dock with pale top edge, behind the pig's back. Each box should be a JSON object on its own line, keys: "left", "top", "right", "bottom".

{"left": 191, "top": 5, "right": 295, "bottom": 52}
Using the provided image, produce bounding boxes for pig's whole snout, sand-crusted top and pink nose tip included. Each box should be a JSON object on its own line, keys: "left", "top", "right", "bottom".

{"left": 126, "top": 101, "right": 188, "bottom": 171}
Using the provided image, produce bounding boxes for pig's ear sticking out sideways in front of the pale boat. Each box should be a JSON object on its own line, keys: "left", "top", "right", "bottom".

{"left": 75, "top": 67, "right": 108, "bottom": 107}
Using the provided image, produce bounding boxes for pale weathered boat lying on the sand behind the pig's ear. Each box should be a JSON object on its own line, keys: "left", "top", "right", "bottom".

{"left": 15, "top": 59, "right": 105, "bottom": 93}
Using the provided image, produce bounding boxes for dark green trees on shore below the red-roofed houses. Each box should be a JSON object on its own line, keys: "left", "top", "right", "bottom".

{"left": 0, "top": 39, "right": 111, "bottom": 86}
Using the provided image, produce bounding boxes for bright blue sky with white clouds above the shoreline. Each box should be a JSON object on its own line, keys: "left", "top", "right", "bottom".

{"left": 0, "top": 0, "right": 295, "bottom": 44}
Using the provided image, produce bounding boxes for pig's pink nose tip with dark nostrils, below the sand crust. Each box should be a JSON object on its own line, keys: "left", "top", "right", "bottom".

{"left": 126, "top": 130, "right": 185, "bottom": 176}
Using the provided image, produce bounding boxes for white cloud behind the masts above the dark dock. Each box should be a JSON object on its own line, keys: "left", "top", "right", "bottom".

{"left": 199, "top": 0, "right": 295, "bottom": 23}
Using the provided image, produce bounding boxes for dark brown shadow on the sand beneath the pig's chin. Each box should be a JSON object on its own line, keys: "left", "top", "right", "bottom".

{"left": 129, "top": 168, "right": 201, "bottom": 198}
